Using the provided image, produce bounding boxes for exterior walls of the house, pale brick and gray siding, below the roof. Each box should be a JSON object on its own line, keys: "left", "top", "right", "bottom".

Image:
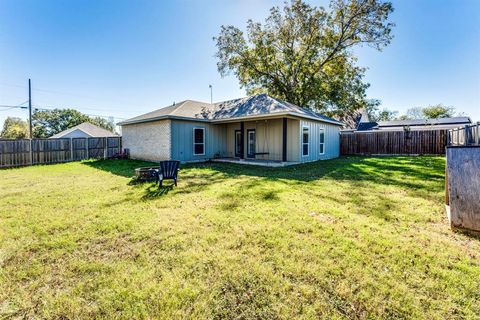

{"left": 122, "top": 118, "right": 340, "bottom": 162}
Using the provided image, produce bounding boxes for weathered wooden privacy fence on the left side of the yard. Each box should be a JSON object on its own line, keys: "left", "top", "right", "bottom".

{"left": 0, "top": 137, "right": 122, "bottom": 168}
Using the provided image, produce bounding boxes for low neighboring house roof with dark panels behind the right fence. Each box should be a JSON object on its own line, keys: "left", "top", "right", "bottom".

{"left": 355, "top": 117, "right": 472, "bottom": 131}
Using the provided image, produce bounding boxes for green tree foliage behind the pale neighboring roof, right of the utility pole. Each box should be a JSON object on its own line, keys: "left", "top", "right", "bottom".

{"left": 32, "top": 109, "right": 115, "bottom": 138}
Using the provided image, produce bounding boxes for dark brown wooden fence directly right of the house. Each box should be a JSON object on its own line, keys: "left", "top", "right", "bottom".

{"left": 340, "top": 129, "right": 448, "bottom": 155}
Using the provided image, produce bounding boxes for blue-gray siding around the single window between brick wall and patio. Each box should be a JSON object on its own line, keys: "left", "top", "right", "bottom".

{"left": 171, "top": 120, "right": 227, "bottom": 162}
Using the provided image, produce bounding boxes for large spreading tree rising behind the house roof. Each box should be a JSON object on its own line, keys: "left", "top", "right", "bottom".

{"left": 214, "top": 0, "right": 393, "bottom": 119}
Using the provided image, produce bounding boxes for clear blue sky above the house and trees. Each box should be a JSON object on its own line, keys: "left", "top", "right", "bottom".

{"left": 0, "top": 0, "right": 480, "bottom": 127}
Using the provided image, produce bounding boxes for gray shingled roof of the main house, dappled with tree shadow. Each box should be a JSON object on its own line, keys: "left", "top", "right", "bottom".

{"left": 118, "top": 94, "right": 342, "bottom": 126}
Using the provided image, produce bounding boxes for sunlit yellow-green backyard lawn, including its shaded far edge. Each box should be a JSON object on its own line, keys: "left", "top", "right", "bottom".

{"left": 0, "top": 157, "right": 480, "bottom": 319}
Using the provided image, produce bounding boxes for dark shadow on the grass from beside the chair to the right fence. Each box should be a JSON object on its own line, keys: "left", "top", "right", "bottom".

{"left": 185, "top": 157, "right": 445, "bottom": 196}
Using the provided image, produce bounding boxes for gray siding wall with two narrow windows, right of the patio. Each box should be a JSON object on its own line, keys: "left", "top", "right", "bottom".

{"left": 298, "top": 120, "right": 340, "bottom": 162}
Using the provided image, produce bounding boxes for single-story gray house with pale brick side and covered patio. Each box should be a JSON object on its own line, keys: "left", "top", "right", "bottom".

{"left": 118, "top": 94, "right": 342, "bottom": 165}
